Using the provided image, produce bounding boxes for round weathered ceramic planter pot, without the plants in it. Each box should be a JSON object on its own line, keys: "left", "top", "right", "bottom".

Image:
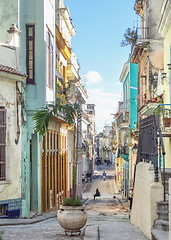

{"left": 57, "top": 206, "right": 87, "bottom": 233}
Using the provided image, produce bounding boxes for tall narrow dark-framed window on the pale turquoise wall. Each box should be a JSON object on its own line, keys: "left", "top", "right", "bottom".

{"left": 26, "top": 25, "right": 35, "bottom": 84}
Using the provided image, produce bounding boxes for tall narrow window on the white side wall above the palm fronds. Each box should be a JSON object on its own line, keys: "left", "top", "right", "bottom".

{"left": 47, "top": 32, "right": 53, "bottom": 88}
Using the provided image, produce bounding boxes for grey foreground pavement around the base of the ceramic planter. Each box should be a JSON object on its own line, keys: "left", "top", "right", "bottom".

{"left": 0, "top": 213, "right": 148, "bottom": 240}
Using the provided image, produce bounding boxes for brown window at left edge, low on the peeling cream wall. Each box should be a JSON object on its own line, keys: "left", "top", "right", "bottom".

{"left": 0, "top": 107, "right": 6, "bottom": 181}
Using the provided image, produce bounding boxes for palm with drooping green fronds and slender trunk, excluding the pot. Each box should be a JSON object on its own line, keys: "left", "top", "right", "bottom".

{"left": 33, "top": 97, "right": 81, "bottom": 199}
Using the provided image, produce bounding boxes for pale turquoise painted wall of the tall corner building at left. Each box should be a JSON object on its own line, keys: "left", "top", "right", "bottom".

{"left": 20, "top": 0, "right": 55, "bottom": 217}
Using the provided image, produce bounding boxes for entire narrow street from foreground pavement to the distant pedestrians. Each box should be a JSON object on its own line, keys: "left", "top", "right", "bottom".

{"left": 0, "top": 165, "right": 147, "bottom": 240}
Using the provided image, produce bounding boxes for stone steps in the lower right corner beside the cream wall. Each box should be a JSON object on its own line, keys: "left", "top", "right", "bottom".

{"left": 151, "top": 201, "right": 169, "bottom": 240}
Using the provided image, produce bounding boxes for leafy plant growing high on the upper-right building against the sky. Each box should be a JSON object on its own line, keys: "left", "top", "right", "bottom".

{"left": 121, "top": 28, "right": 137, "bottom": 47}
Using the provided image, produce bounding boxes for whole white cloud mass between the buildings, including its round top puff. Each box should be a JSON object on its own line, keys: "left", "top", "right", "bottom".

{"left": 81, "top": 71, "right": 121, "bottom": 132}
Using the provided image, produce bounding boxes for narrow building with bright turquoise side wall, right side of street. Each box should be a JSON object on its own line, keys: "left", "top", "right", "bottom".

{"left": 120, "top": 56, "right": 138, "bottom": 198}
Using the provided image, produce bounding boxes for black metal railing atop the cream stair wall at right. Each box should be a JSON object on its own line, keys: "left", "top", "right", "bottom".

{"left": 134, "top": 112, "right": 166, "bottom": 201}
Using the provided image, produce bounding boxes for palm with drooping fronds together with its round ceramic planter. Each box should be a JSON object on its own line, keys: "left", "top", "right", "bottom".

{"left": 33, "top": 97, "right": 87, "bottom": 233}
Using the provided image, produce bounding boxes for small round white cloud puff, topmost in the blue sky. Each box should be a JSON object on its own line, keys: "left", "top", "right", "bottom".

{"left": 81, "top": 71, "right": 102, "bottom": 85}
